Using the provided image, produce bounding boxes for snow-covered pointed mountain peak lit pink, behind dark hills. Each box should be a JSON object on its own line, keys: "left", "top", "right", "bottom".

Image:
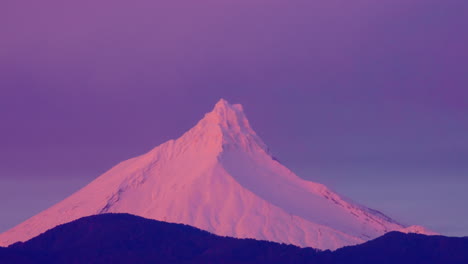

{"left": 0, "top": 100, "right": 432, "bottom": 249}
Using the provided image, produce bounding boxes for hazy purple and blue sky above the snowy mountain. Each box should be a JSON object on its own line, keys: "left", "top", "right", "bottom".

{"left": 0, "top": 0, "right": 468, "bottom": 236}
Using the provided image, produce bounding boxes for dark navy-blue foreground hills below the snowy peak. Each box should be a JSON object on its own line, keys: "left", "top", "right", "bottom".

{"left": 0, "top": 214, "right": 468, "bottom": 264}
